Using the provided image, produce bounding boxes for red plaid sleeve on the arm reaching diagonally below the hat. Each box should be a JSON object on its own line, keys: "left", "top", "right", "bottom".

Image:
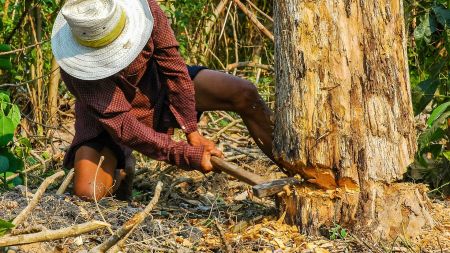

{"left": 61, "top": 71, "right": 203, "bottom": 169}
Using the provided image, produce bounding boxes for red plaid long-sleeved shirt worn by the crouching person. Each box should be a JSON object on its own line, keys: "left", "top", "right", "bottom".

{"left": 61, "top": 0, "right": 203, "bottom": 168}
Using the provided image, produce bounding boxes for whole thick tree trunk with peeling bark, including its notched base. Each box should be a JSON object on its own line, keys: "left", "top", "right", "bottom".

{"left": 274, "top": 0, "right": 433, "bottom": 240}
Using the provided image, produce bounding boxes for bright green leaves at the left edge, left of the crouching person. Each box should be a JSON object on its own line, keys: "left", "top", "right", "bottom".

{"left": 0, "top": 92, "right": 27, "bottom": 188}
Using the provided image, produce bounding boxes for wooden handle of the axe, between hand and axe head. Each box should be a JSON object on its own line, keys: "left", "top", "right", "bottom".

{"left": 211, "top": 156, "right": 267, "bottom": 186}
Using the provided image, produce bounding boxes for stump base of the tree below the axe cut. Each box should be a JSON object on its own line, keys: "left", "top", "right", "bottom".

{"left": 277, "top": 183, "right": 435, "bottom": 240}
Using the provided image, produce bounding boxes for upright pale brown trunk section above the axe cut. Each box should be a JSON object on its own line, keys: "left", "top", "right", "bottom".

{"left": 274, "top": 0, "right": 415, "bottom": 182}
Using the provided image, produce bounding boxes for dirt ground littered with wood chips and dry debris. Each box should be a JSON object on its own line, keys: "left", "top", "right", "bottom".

{"left": 0, "top": 115, "right": 450, "bottom": 253}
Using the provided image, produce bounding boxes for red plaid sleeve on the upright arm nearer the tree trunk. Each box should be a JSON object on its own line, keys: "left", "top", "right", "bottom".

{"left": 149, "top": 0, "right": 197, "bottom": 134}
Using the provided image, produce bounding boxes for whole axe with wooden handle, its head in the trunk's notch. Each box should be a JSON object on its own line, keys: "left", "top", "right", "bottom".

{"left": 211, "top": 156, "right": 301, "bottom": 198}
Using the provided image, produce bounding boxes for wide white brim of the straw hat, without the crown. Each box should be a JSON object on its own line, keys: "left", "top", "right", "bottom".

{"left": 52, "top": 0, "right": 154, "bottom": 80}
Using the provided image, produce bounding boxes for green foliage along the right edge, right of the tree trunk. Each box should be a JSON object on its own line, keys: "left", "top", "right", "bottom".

{"left": 406, "top": 0, "right": 450, "bottom": 195}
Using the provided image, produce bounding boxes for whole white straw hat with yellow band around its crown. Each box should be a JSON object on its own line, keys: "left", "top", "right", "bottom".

{"left": 52, "top": 0, "right": 153, "bottom": 80}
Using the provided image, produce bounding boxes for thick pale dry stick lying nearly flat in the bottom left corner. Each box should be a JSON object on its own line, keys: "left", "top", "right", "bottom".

{"left": 0, "top": 221, "right": 110, "bottom": 247}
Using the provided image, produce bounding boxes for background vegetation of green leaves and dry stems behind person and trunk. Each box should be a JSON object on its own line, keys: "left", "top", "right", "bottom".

{"left": 0, "top": 0, "right": 450, "bottom": 195}
